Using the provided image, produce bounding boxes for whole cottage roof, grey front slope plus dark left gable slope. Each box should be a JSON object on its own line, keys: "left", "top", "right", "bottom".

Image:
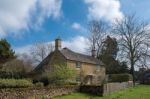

{"left": 34, "top": 48, "right": 103, "bottom": 71}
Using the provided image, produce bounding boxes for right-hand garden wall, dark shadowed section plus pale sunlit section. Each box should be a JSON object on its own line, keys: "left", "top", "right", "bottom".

{"left": 80, "top": 82, "right": 133, "bottom": 96}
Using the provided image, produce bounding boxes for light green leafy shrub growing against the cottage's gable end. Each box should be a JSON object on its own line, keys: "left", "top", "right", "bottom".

{"left": 40, "top": 64, "right": 75, "bottom": 86}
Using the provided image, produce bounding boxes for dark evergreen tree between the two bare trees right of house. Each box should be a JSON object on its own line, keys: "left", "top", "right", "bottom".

{"left": 98, "top": 36, "right": 128, "bottom": 74}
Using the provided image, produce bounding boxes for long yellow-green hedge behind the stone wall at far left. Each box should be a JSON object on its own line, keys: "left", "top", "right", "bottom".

{"left": 0, "top": 79, "right": 33, "bottom": 88}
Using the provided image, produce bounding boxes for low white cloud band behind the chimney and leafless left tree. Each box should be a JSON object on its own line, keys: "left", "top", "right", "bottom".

{"left": 14, "top": 36, "right": 88, "bottom": 55}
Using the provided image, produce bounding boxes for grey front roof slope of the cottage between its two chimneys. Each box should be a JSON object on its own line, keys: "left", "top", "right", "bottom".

{"left": 60, "top": 48, "right": 102, "bottom": 65}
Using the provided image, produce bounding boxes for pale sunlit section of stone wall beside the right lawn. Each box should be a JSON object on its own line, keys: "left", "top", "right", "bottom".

{"left": 103, "top": 81, "right": 133, "bottom": 96}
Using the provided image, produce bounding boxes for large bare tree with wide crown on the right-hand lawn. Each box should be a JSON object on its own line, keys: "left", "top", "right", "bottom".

{"left": 113, "top": 15, "right": 150, "bottom": 84}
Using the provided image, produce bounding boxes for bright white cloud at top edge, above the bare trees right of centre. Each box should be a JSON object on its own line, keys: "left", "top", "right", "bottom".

{"left": 84, "top": 0, "right": 123, "bottom": 22}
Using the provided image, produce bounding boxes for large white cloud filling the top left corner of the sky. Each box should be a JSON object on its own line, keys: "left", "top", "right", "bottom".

{"left": 0, "top": 0, "right": 62, "bottom": 38}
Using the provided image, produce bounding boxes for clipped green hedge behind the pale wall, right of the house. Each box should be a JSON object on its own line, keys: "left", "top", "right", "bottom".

{"left": 109, "top": 74, "right": 132, "bottom": 82}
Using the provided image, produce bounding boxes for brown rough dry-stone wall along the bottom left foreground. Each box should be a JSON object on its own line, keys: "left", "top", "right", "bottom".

{"left": 0, "top": 86, "right": 79, "bottom": 99}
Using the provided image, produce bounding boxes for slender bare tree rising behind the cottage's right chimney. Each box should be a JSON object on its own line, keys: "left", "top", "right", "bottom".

{"left": 88, "top": 20, "right": 109, "bottom": 56}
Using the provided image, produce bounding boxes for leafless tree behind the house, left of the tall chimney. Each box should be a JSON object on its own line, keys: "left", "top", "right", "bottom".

{"left": 31, "top": 43, "right": 54, "bottom": 63}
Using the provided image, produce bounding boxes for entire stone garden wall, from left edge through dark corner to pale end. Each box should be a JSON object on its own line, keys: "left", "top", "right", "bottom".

{"left": 0, "top": 82, "right": 133, "bottom": 99}
